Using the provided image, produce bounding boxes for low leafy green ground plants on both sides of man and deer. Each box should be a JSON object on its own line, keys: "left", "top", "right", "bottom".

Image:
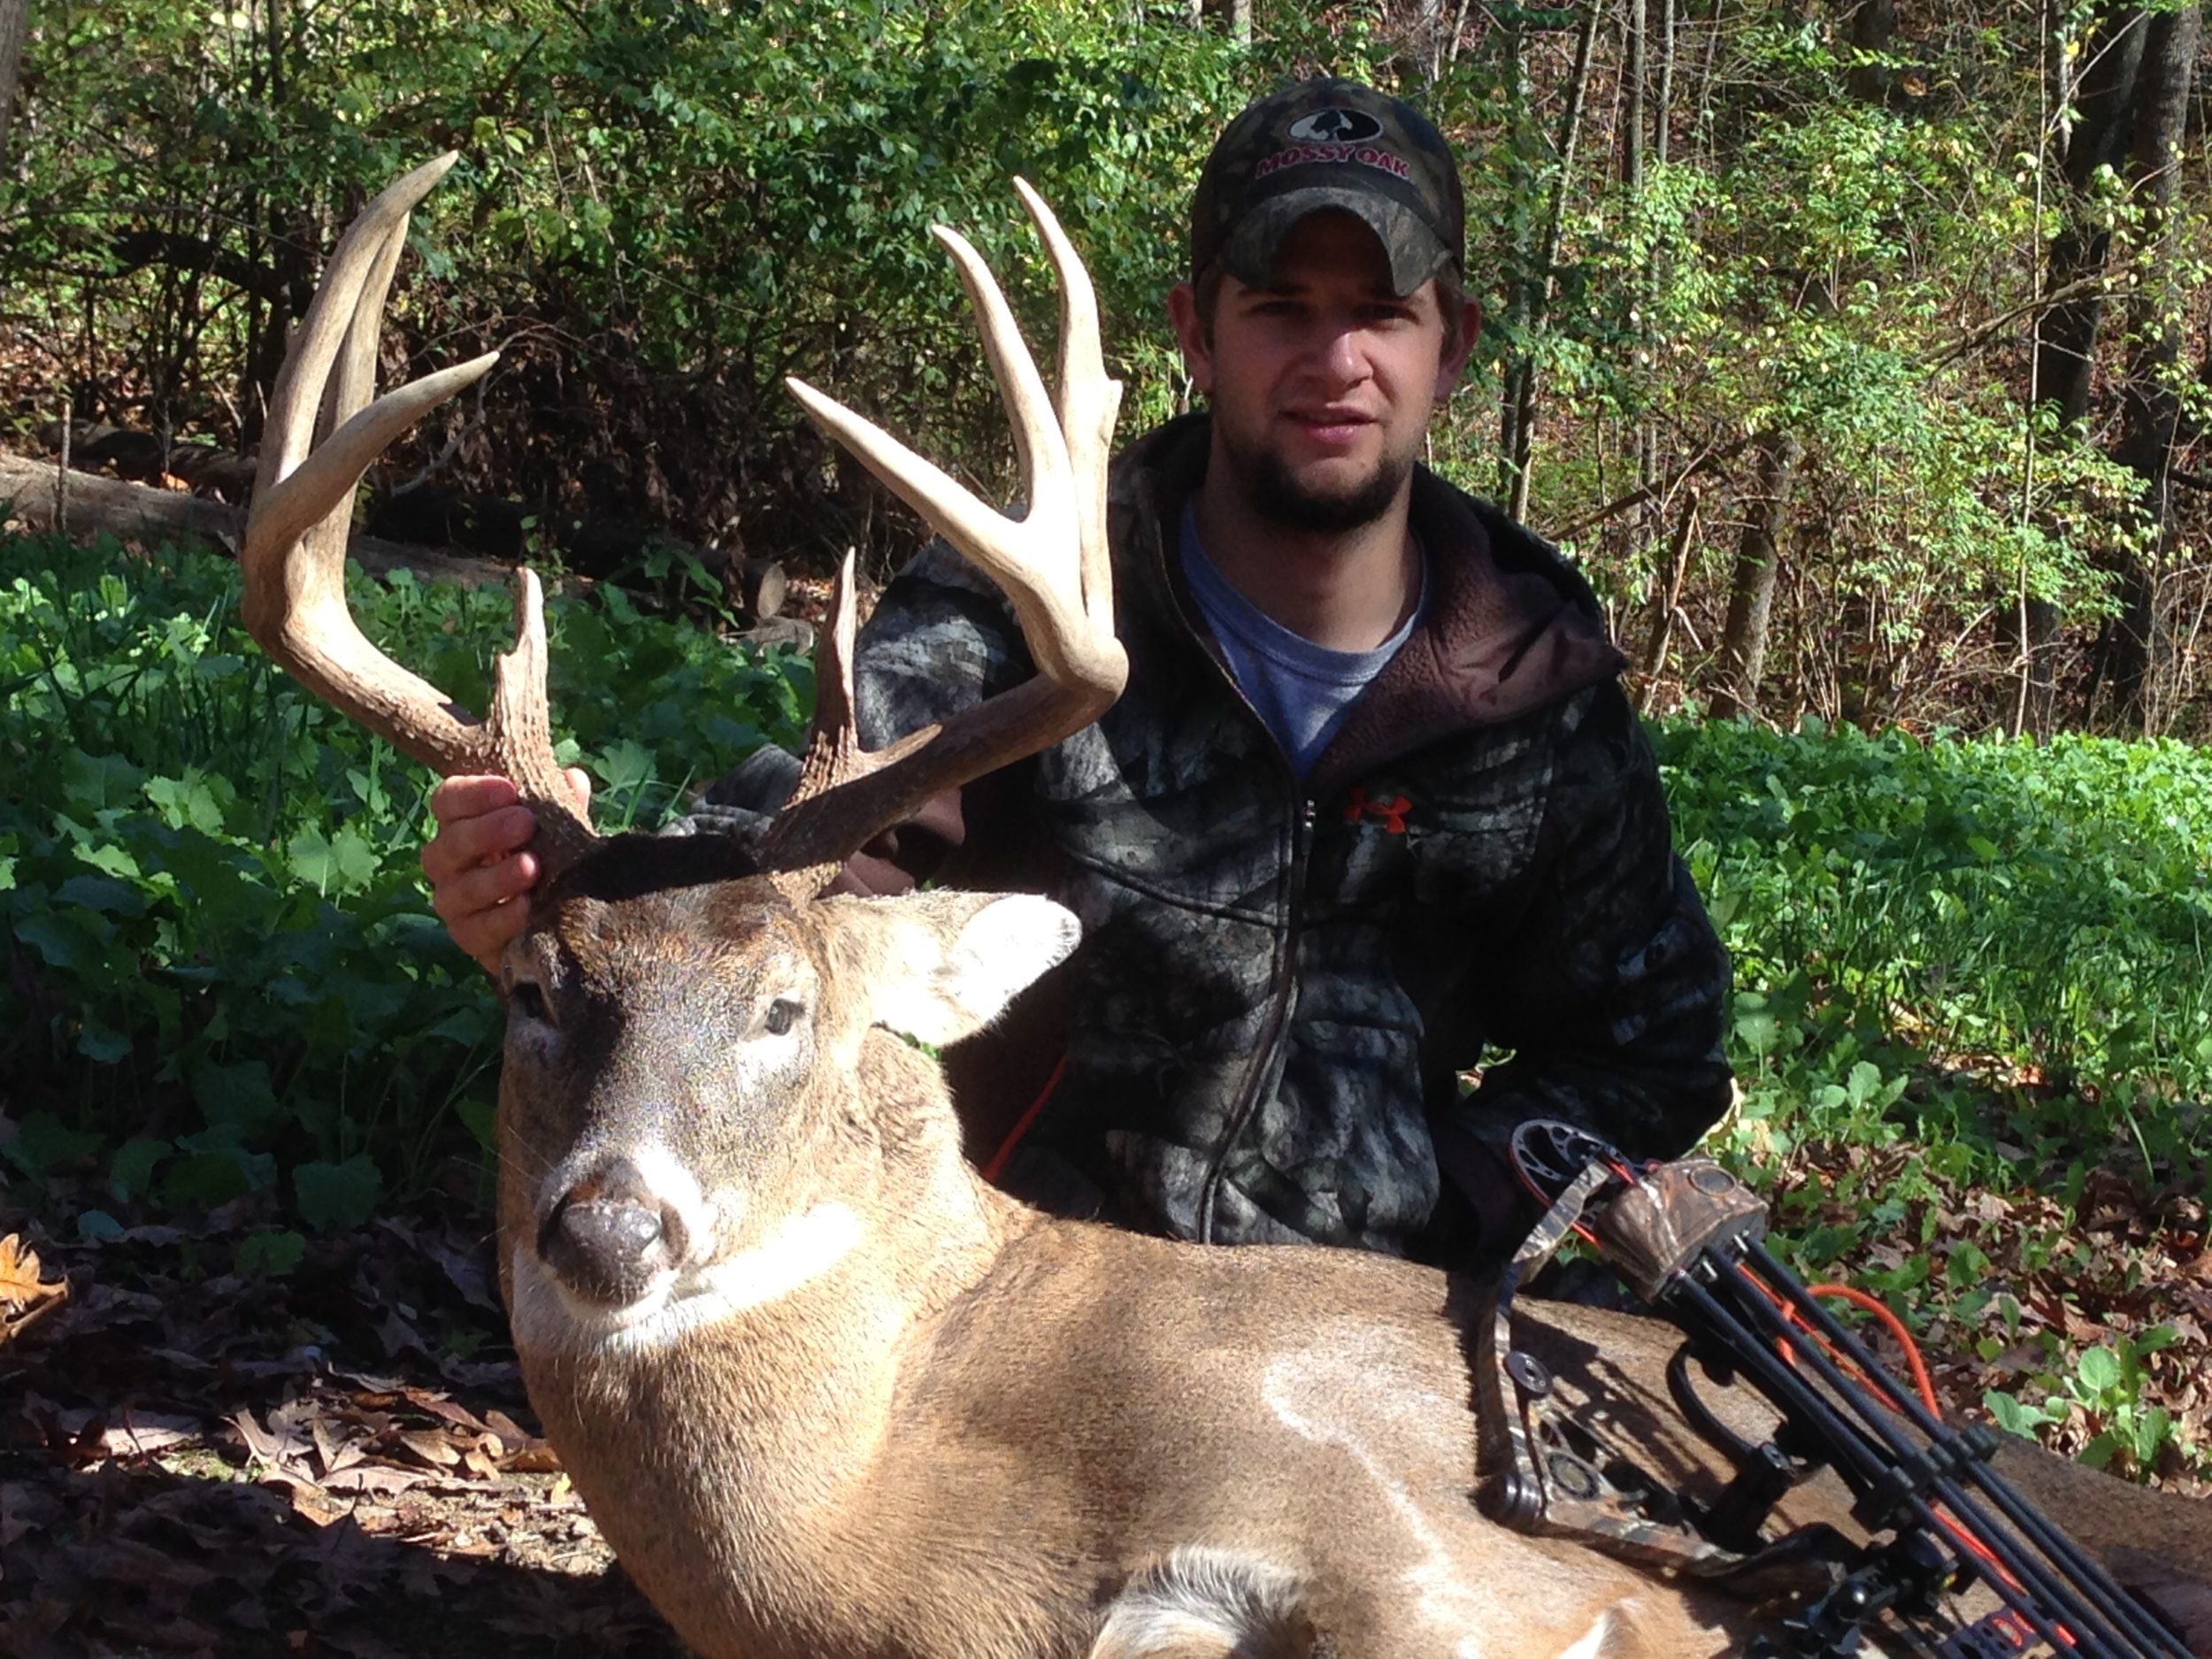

{"left": 0, "top": 538, "right": 2212, "bottom": 1471}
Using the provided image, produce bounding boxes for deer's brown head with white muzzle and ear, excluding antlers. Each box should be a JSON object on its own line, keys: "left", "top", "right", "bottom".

{"left": 500, "top": 836, "right": 1078, "bottom": 1349}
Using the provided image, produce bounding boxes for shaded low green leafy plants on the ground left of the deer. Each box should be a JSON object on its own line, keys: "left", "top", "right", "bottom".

{"left": 0, "top": 538, "right": 812, "bottom": 1228}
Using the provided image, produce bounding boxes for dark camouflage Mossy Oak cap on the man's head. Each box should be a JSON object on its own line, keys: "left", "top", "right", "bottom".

{"left": 1190, "top": 75, "right": 1467, "bottom": 296}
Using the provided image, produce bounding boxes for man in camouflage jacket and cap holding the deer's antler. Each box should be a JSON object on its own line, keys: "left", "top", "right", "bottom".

{"left": 423, "top": 80, "right": 1728, "bottom": 1268}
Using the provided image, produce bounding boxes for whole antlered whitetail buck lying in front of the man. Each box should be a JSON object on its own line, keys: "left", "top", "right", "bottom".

{"left": 246, "top": 159, "right": 2212, "bottom": 1659}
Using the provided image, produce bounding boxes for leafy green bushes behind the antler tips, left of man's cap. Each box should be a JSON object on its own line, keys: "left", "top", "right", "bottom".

{"left": 12, "top": 0, "right": 1268, "bottom": 556}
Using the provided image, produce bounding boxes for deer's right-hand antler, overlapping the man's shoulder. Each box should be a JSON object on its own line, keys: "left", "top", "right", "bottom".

{"left": 764, "top": 180, "right": 1128, "bottom": 889}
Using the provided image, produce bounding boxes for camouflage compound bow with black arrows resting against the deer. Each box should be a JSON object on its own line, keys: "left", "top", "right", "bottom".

{"left": 1476, "top": 1124, "right": 2188, "bottom": 1659}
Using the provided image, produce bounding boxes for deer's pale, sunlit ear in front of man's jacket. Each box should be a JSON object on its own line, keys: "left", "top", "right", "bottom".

{"left": 823, "top": 892, "right": 1082, "bottom": 1044}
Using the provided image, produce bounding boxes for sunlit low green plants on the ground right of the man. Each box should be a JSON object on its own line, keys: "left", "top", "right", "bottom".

{"left": 1657, "top": 724, "right": 2212, "bottom": 1184}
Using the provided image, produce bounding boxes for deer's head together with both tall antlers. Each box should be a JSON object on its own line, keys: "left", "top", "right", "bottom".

{"left": 243, "top": 157, "right": 1126, "bottom": 1336}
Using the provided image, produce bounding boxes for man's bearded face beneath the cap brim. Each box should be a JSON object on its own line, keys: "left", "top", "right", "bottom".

{"left": 1168, "top": 212, "right": 1478, "bottom": 531}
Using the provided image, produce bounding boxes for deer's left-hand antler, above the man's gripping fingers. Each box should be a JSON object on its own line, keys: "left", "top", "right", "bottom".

{"left": 242, "top": 153, "right": 593, "bottom": 874}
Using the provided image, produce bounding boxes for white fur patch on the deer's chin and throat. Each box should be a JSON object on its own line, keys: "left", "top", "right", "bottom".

{"left": 511, "top": 1202, "right": 867, "bottom": 1354}
